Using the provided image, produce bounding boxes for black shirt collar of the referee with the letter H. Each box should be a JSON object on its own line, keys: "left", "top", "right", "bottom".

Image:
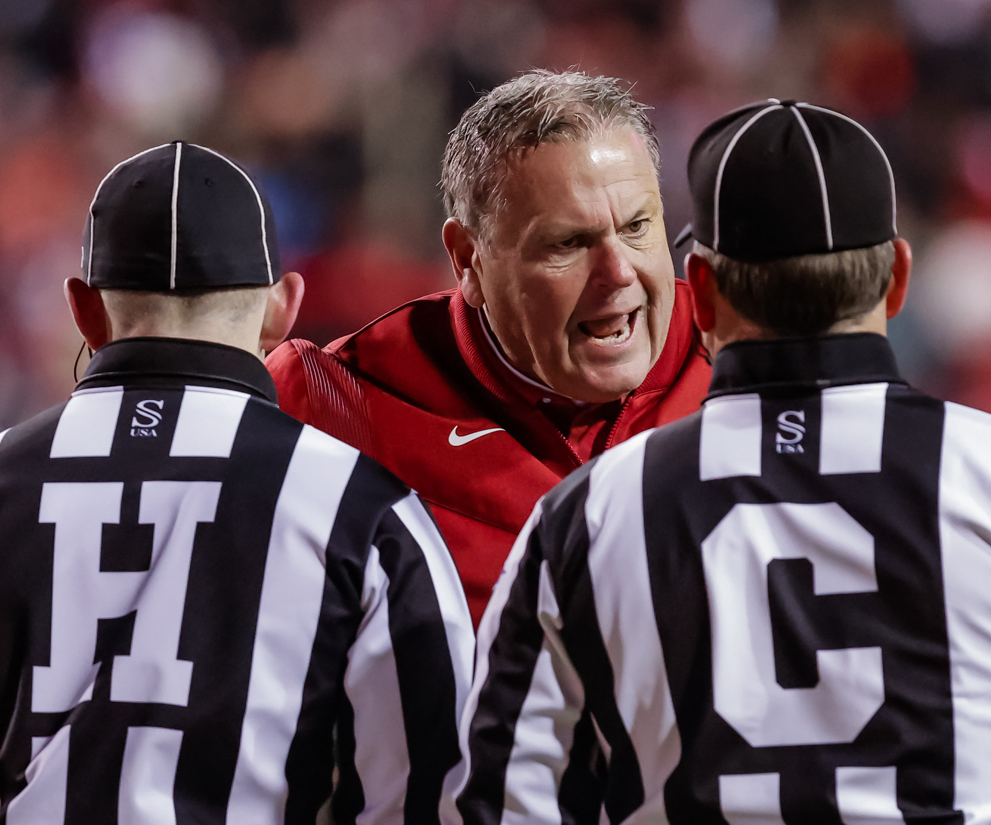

{"left": 76, "top": 338, "right": 279, "bottom": 404}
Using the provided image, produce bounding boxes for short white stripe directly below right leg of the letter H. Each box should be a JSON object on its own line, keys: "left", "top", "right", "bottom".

{"left": 117, "top": 727, "right": 182, "bottom": 825}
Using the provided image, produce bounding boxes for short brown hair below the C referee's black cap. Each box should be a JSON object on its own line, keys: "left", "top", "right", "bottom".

{"left": 692, "top": 241, "right": 895, "bottom": 337}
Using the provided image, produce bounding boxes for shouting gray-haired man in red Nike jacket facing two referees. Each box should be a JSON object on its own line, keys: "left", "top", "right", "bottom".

{"left": 267, "top": 71, "right": 709, "bottom": 622}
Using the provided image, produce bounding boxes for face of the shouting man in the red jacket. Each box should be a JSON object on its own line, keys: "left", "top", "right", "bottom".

{"left": 445, "top": 127, "right": 674, "bottom": 402}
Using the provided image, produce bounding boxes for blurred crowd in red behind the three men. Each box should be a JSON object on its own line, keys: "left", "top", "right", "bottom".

{"left": 0, "top": 0, "right": 991, "bottom": 427}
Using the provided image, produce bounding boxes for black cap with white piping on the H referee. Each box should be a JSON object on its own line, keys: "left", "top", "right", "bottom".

{"left": 82, "top": 140, "right": 281, "bottom": 292}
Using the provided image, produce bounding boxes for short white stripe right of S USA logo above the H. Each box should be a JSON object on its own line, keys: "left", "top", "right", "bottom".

{"left": 169, "top": 387, "right": 248, "bottom": 458}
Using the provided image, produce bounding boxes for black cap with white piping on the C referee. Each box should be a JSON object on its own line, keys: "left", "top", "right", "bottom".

{"left": 675, "top": 99, "right": 897, "bottom": 263}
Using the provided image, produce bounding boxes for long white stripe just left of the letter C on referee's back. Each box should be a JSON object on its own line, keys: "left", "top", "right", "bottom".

{"left": 585, "top": 431, "right": 681, "bottom": 821}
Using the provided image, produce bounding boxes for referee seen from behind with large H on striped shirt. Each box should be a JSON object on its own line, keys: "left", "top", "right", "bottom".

{"left": 0, "top": 142, "right": 473, "bottom": 825}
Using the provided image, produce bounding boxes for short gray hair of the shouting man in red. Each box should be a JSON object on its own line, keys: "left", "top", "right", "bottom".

{"left": 441, "top": 69, "right": 660, "bottom": 237}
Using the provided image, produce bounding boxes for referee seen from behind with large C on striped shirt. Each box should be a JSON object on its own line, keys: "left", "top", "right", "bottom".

{"left": 458, "top": 100, "right": 991, "bottom": 825}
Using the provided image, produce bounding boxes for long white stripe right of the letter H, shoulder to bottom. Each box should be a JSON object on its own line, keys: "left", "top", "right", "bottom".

{"left": 226, "top": 426, "right": 358, "bottom": 825}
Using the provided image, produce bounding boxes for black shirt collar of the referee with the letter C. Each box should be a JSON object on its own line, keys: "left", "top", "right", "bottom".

{"left": 707, "top": 332, "right": 907, "bottom": 399}
